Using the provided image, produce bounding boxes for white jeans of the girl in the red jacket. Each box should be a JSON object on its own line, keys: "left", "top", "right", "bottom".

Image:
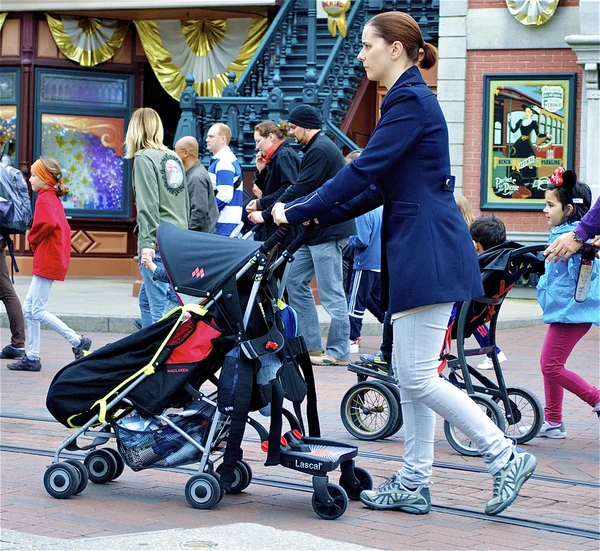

{"left": 23, "top": 276, "right": 81, "bottom": 360}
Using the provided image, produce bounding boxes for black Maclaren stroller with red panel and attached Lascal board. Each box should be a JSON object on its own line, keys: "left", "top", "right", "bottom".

{"left": 44, "top": 224, "right": 372, "bottom": 519}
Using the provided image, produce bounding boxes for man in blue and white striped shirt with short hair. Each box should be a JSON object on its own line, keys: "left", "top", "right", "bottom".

{"left": 206, "top": 122, "right": 244, "bottom": 236}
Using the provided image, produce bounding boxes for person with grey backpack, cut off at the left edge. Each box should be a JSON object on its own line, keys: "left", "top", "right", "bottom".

{"left": 0, "top": 164, "right": 32, "bottom": 360}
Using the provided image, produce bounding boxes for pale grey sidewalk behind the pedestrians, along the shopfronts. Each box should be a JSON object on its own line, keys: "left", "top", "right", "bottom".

{"left": 0, "top": 276, "right": 542, "bottom": 336}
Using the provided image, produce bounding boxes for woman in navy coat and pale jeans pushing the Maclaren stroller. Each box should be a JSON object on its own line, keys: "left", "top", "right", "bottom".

{"left": 274, "top": 12, "right": 537, "bottom": 515}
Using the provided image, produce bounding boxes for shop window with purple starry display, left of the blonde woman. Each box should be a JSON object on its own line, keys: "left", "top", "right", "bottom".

{"left": 35, "top": 69, "right": 133, "bottom": 218}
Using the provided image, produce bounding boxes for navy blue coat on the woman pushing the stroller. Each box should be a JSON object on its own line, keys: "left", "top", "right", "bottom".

{"left": 285, "top": 66, "right": 483, "bottom": 313}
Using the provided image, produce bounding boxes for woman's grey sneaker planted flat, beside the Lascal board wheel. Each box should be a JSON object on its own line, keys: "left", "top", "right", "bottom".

{"left": 360, "top": 474, "right": 431, "bottom": 515}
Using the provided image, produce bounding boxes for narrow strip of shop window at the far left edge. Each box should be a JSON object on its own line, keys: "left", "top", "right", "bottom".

{"left": 0, "top": 68, "right": 19, "bottom": 166}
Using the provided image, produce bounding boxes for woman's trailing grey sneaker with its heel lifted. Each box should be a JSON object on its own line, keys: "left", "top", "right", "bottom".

{"left": 485, "top": 448, "right": 537, "bottom": 515}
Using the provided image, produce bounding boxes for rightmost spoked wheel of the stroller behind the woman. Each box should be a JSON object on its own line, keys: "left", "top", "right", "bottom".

{"left": 493, "top": 387, "right": 544, "bottom": 444}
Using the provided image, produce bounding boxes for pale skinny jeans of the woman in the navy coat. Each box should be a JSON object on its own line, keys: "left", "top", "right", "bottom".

{"left": 392, "top": 303, "right": 513, "bottom": 486}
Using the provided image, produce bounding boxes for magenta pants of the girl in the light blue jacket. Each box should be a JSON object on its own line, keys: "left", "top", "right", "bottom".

{"left": 540, "top": 323, "right": 600, "bottom": 423}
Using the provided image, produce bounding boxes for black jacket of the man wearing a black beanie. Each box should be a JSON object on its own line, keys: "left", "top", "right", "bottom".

{"left": 263, "top": 132, "right": 356, "bottom": 245}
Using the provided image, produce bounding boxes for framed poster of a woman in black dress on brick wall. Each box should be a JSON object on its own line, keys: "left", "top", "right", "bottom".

{"left": 480, "top": 73, "right": 576, "bottom": 210}
